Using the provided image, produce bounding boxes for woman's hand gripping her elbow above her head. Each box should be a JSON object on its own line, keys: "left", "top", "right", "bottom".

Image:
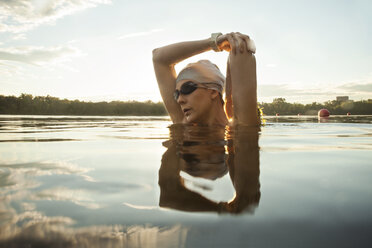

{"left": 217, "top": 32, "right": 256, "bottom": 54}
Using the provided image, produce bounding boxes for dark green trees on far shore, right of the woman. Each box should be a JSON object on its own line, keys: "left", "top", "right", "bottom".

{"left": 259, "top": 98, "right": 372, "bottom": 115}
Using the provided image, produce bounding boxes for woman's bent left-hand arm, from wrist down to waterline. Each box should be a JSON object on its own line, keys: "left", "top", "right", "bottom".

{"left": 152, "top": 39, "right": 212, "bottom": 123}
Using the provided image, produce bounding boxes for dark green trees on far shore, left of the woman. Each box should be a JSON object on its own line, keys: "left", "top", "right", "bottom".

{"left": 0, "top": 94, "right": 167, "bottom": 116}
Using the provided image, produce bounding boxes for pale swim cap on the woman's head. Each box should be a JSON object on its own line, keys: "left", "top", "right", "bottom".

{"left": 176, "top": 60, "right": 226, "bottom": 95}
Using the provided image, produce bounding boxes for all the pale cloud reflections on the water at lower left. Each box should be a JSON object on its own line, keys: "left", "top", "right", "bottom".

{"left": 0, "top": 161, "right": 188, "bottom": 248}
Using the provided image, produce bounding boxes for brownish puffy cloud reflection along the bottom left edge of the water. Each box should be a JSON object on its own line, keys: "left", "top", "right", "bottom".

{"left": 0, "top": 211, "right": 189, "bottom": 248}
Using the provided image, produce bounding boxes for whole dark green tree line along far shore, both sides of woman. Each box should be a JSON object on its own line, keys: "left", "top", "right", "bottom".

{"left": 0, "top": 94, "right": 372, "bottom": 116}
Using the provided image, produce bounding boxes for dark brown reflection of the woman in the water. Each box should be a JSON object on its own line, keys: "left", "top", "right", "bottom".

{"left": 159, "top": 124, "right": 261, "bottom": 214}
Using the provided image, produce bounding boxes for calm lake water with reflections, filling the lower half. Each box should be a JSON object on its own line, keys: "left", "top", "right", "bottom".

{"left": 0, "top": 116, "right": 372, "bottom": 247}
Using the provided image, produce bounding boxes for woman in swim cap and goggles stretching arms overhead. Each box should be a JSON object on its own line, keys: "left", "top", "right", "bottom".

{"left": 153, "top": 33, "right": 259, "bottom": 126}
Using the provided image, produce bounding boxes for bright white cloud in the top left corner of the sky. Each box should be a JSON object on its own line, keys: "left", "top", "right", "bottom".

{"left": 0, "top": 0, "right": 111, "bottom": 33}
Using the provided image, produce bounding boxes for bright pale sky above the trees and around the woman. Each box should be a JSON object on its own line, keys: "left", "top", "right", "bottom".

{"left": 0, "top": 0, "right": 372, "bottom": 103}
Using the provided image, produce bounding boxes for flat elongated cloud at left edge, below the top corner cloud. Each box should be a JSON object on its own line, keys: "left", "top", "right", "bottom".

{"left": 0, "top": 46, "right": 81, "bottom": 65}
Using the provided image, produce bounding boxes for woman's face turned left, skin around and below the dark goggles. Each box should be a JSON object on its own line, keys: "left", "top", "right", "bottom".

{"left": 176, "top": 82, "right": 214, "bottom": 124}
